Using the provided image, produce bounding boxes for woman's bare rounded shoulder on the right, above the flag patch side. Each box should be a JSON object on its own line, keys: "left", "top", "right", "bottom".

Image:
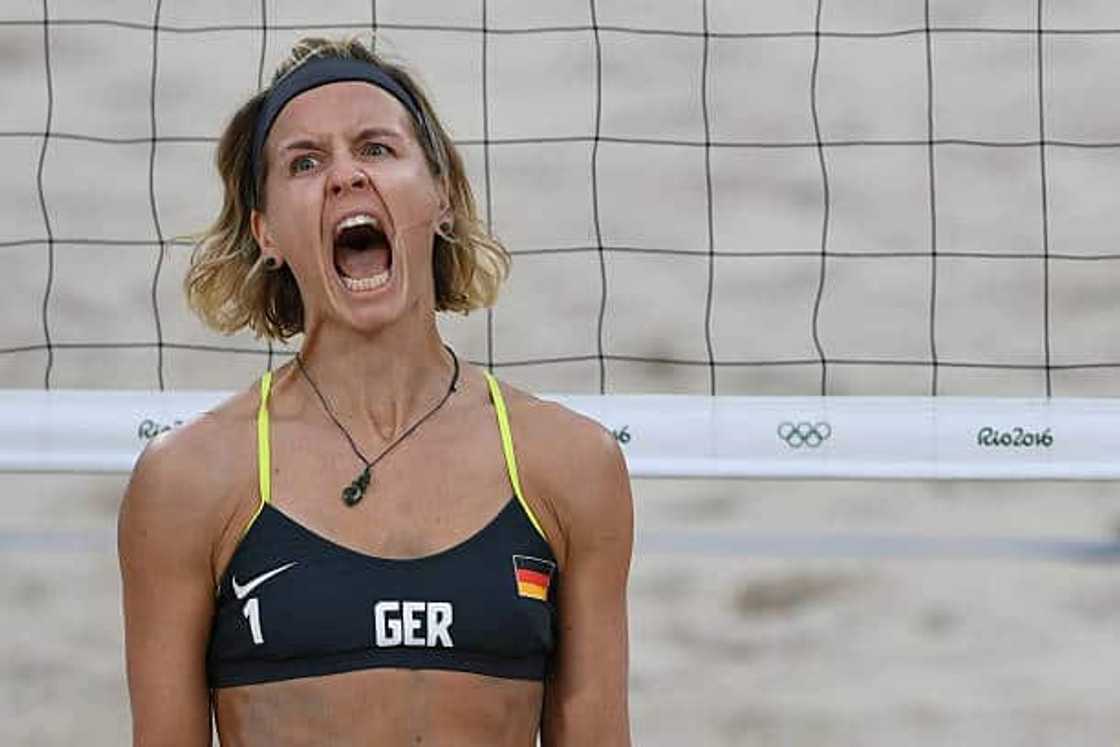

{"left": 503, "top": 385, "right": 633, "bottom": 559}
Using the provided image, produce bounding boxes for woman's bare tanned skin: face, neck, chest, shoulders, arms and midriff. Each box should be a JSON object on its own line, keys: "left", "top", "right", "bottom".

{"left": 119, "top": 74, "right": 633, "bottom": 747}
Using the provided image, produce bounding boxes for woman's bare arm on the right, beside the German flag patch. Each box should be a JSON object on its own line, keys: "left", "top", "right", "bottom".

{"left": 541, "top": 421, "right": 634, "bottom": 747}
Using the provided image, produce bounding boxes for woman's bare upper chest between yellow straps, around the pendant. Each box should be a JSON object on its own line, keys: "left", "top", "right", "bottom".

{"left": 262, "top": 403, "right": 513, "bottom": 558}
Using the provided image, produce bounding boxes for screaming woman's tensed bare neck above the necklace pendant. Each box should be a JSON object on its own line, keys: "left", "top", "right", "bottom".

{"left": 292, "top": 316, "right": 452, "bottom": 447}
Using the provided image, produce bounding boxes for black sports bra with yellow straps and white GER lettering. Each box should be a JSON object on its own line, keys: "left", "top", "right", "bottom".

{"left": 206, "top": 372, "right": 558, "bottom": 688}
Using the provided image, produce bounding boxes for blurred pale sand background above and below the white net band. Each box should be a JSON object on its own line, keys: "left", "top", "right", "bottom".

{"left": 0, "top": 0, "right": 1120, "bottom": 747}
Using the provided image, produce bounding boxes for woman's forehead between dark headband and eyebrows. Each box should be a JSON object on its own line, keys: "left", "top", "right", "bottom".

{"left": 269, "top": 81, "right": 412, "bottom": 146}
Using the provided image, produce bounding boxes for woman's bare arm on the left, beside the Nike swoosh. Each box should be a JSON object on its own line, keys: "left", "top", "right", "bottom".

{"left": 118, "top": 437, "right": 227, "bottom": 747}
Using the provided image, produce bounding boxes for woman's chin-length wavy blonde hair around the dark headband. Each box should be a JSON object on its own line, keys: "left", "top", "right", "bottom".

{"left": 184, "top": 37, "right": 510, "bottom": 340}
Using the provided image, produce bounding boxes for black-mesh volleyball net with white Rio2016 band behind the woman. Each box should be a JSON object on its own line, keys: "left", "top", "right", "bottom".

{"left": 0, "top": 0, "right": 1120, "bottom": 478}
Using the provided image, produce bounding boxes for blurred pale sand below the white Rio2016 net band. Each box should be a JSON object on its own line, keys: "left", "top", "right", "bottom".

{"left": 0, "top": 475, "right": 1120, "bottom": 747}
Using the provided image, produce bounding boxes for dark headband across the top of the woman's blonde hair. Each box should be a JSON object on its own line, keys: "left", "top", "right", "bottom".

{"left": 250, "top": 57, "right": 430, "bottom": 205}
